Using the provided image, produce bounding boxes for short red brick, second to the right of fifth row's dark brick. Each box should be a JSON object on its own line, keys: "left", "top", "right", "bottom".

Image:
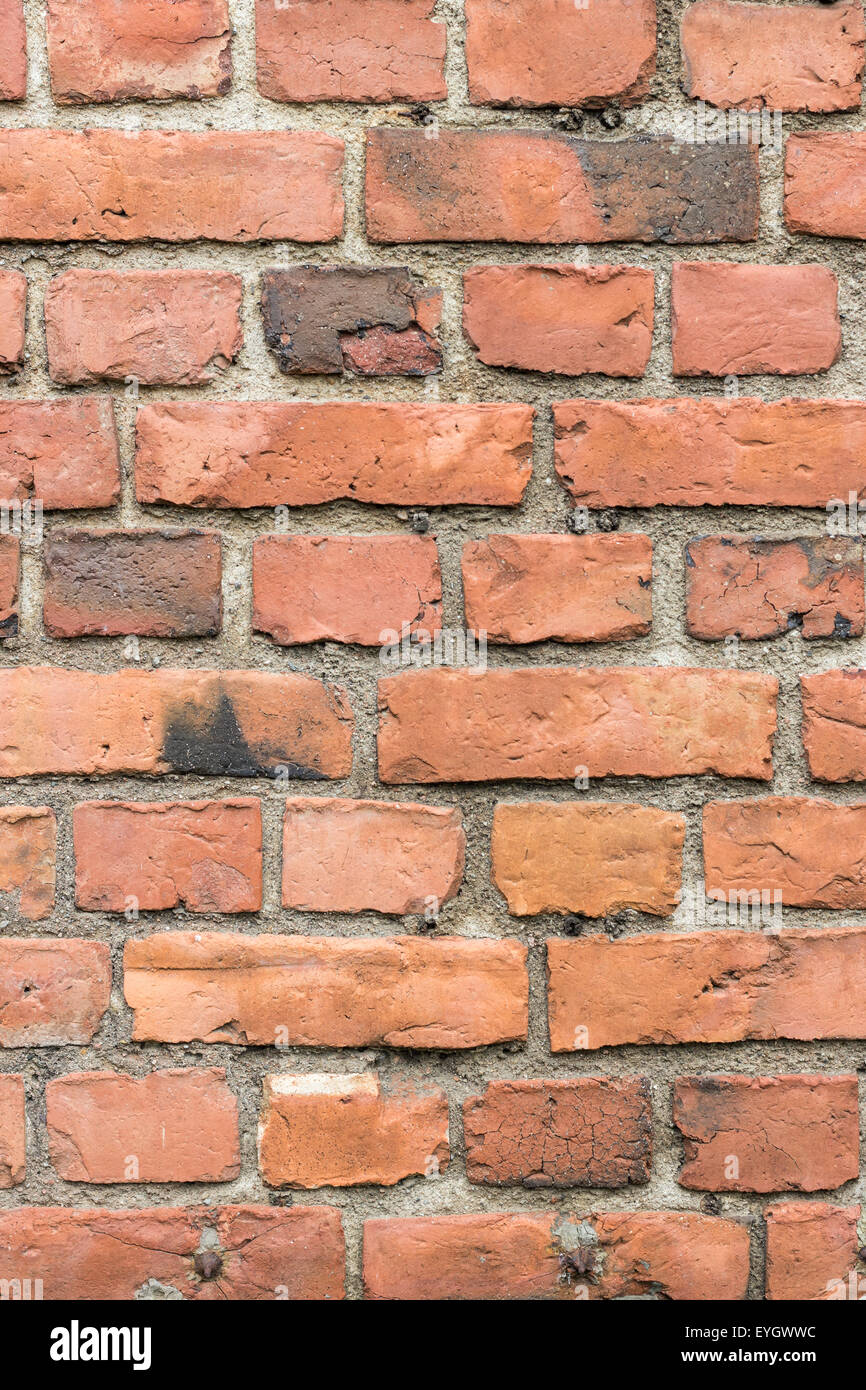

{"left": 463, "top": 535, "right": 652, "bottom": 642}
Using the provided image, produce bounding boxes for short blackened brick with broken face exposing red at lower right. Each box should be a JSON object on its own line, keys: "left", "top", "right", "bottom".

{"left": 261, "top": 265, "right": 442, "bottom": 377}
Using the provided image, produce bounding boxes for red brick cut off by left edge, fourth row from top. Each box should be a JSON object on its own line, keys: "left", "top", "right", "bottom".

{"left": 0, "top": 397, "right": 120, "bottom": 510}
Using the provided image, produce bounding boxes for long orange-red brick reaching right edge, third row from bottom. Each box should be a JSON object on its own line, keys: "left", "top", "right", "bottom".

{"left": 548, "top": 927, "right": 866, "bottom": 1052}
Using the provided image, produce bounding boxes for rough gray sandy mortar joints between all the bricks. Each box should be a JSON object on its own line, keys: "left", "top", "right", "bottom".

{"left": 0, "top": 0, "right": 866, "bottom": 1298}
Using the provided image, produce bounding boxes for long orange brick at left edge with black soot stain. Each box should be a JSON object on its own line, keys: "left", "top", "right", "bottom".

{"left": 0, "top": 666, "right": 353, "bottom": 778}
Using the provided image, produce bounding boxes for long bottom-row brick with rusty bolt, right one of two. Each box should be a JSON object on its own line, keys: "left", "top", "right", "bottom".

{"left": 364, "top": 1212, "right": 749, "bottom": 1301}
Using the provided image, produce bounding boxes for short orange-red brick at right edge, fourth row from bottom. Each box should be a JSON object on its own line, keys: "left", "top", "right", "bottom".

{"left": 703, "top": 796, "right": 866, "bottom": 908}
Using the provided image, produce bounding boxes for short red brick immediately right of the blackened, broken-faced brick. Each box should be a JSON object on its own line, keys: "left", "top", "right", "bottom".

{"left": 463, "top": 265, "right": 653, "bottom": 377}
